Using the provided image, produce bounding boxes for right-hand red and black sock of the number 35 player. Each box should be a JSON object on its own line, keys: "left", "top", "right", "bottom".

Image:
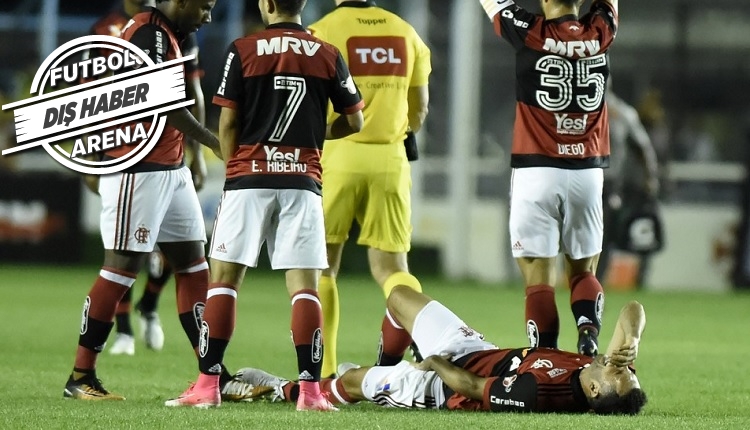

{"left": 570, "top": 272, "right": 604, "bottom": 335}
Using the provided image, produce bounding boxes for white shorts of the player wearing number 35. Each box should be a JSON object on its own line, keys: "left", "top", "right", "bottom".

{"left": 509, "top": 167, "right": 604, "bottom": 260}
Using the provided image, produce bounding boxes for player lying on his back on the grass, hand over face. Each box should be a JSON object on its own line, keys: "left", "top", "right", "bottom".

{"left": 237, "top": 286, "right": 646, "bottom": 415}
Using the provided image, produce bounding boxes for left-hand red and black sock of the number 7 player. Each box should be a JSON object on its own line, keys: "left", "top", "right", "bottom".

{"left": 198, "top": 284, "right": 237, "bottom": 375}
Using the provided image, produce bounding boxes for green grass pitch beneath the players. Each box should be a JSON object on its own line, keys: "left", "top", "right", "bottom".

{"left": 0, "top": 265, "right": 750, "bottom": 430}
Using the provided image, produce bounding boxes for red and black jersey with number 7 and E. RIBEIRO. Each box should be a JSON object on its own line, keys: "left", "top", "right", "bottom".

{"left": 213, "top": 23, "right": 364, "bottom": 194}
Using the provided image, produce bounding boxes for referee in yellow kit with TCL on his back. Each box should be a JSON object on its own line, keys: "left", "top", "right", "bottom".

{"left": 309, "top": 0, "right": 432, "bottom": 376}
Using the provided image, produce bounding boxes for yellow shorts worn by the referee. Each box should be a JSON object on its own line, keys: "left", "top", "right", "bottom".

{"left": 321, "top": 139, "right": 412, "bottom": 252}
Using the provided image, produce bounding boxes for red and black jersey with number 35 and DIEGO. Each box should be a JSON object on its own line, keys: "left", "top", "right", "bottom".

{"left": 482, "top": 0, "right": 618, "bottom": 169}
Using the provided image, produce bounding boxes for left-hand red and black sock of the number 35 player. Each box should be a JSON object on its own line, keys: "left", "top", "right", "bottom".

{"left": 526, "top": 285, "right": 560, "bottom": 348}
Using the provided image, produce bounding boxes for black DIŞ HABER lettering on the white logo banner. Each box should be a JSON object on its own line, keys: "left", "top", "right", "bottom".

{"left": 44, "top": 83, "right": 149, "bottom": 128}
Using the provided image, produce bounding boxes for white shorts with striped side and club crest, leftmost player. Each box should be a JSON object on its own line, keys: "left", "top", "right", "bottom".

{"left": 99, "top": 167, "right": 206, "bottom": 252}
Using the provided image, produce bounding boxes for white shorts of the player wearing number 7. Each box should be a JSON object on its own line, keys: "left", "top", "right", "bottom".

{"left": 209, "top": 189, "right": 328, "bottom": 270}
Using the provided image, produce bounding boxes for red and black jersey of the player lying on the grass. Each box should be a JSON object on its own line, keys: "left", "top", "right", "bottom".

{"left": 445, "top": 348, "right": 593, "bottom": 412}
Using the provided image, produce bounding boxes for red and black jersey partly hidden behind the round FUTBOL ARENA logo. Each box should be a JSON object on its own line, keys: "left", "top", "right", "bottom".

{"left": 106, "top": 8, "right": 185, "bottom": 172}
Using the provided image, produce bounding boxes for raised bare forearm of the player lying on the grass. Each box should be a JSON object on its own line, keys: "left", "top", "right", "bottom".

{"left": 606, "top": 300, "right": 646, "bottom": 367}
